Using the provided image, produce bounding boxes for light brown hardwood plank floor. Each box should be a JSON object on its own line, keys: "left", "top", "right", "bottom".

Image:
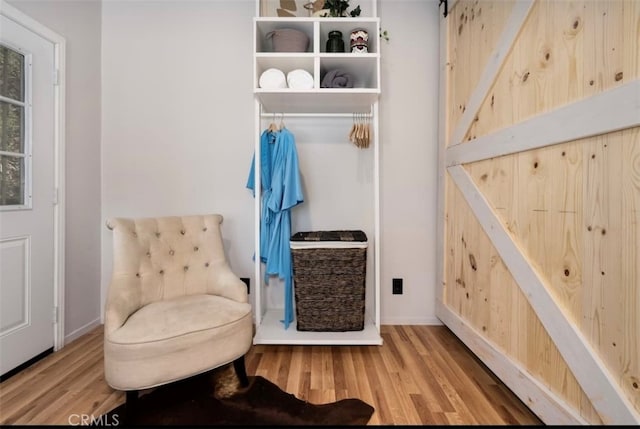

{"left": 0, "top": 326, "right": 542, "bottom": 425}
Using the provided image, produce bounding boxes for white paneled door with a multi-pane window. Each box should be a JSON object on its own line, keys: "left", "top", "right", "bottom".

{"left": 0, "top": 12, "right": 55, "bottom": 375}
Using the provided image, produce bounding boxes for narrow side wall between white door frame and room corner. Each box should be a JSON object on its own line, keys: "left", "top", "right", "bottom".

{"left": 8, "top": 0, "right": 101, "bottom": 341}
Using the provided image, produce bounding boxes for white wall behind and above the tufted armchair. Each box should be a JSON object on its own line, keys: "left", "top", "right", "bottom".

{"left": 100, "top": 0, "right": 255, "bottom": 308}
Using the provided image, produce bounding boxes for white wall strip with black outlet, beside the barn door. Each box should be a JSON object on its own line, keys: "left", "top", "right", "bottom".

{"left": 378, "top": 0, "right": 440, "bottom": 324}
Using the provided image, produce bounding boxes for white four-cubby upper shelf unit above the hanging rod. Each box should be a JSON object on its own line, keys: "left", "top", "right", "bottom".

{"left": 253, "top": 17, "right": 380, "bottom": 113}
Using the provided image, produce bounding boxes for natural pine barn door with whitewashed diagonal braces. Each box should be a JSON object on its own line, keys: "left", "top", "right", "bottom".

{"left": 437, "top": 0, "right": 640, "bottom": 424}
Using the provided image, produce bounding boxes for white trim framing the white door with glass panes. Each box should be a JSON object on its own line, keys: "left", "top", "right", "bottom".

{"left": 0, "top": 0, "right": 66, "bottom": 351}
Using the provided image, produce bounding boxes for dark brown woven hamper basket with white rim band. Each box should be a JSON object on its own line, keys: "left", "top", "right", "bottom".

{"left": 291, "top": 231, "right": 367, "bottom": 332}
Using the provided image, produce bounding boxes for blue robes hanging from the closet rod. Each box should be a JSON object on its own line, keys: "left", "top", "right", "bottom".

{"left": 247, "top": 128, "right": 304, "bottom": 329}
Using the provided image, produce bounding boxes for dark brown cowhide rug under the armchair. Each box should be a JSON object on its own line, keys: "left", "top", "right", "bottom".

{"left": 101, "top": 365, "right": 374, "bottom": 426}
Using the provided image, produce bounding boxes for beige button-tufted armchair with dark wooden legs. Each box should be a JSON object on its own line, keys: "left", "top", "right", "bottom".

{"left": 104, "top": 214, "right": 253, "bottom": 404}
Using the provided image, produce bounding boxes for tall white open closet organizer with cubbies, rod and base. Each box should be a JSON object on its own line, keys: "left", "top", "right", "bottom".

{"left": 253, "top": 1, "right": 382, "bottom": 345}
